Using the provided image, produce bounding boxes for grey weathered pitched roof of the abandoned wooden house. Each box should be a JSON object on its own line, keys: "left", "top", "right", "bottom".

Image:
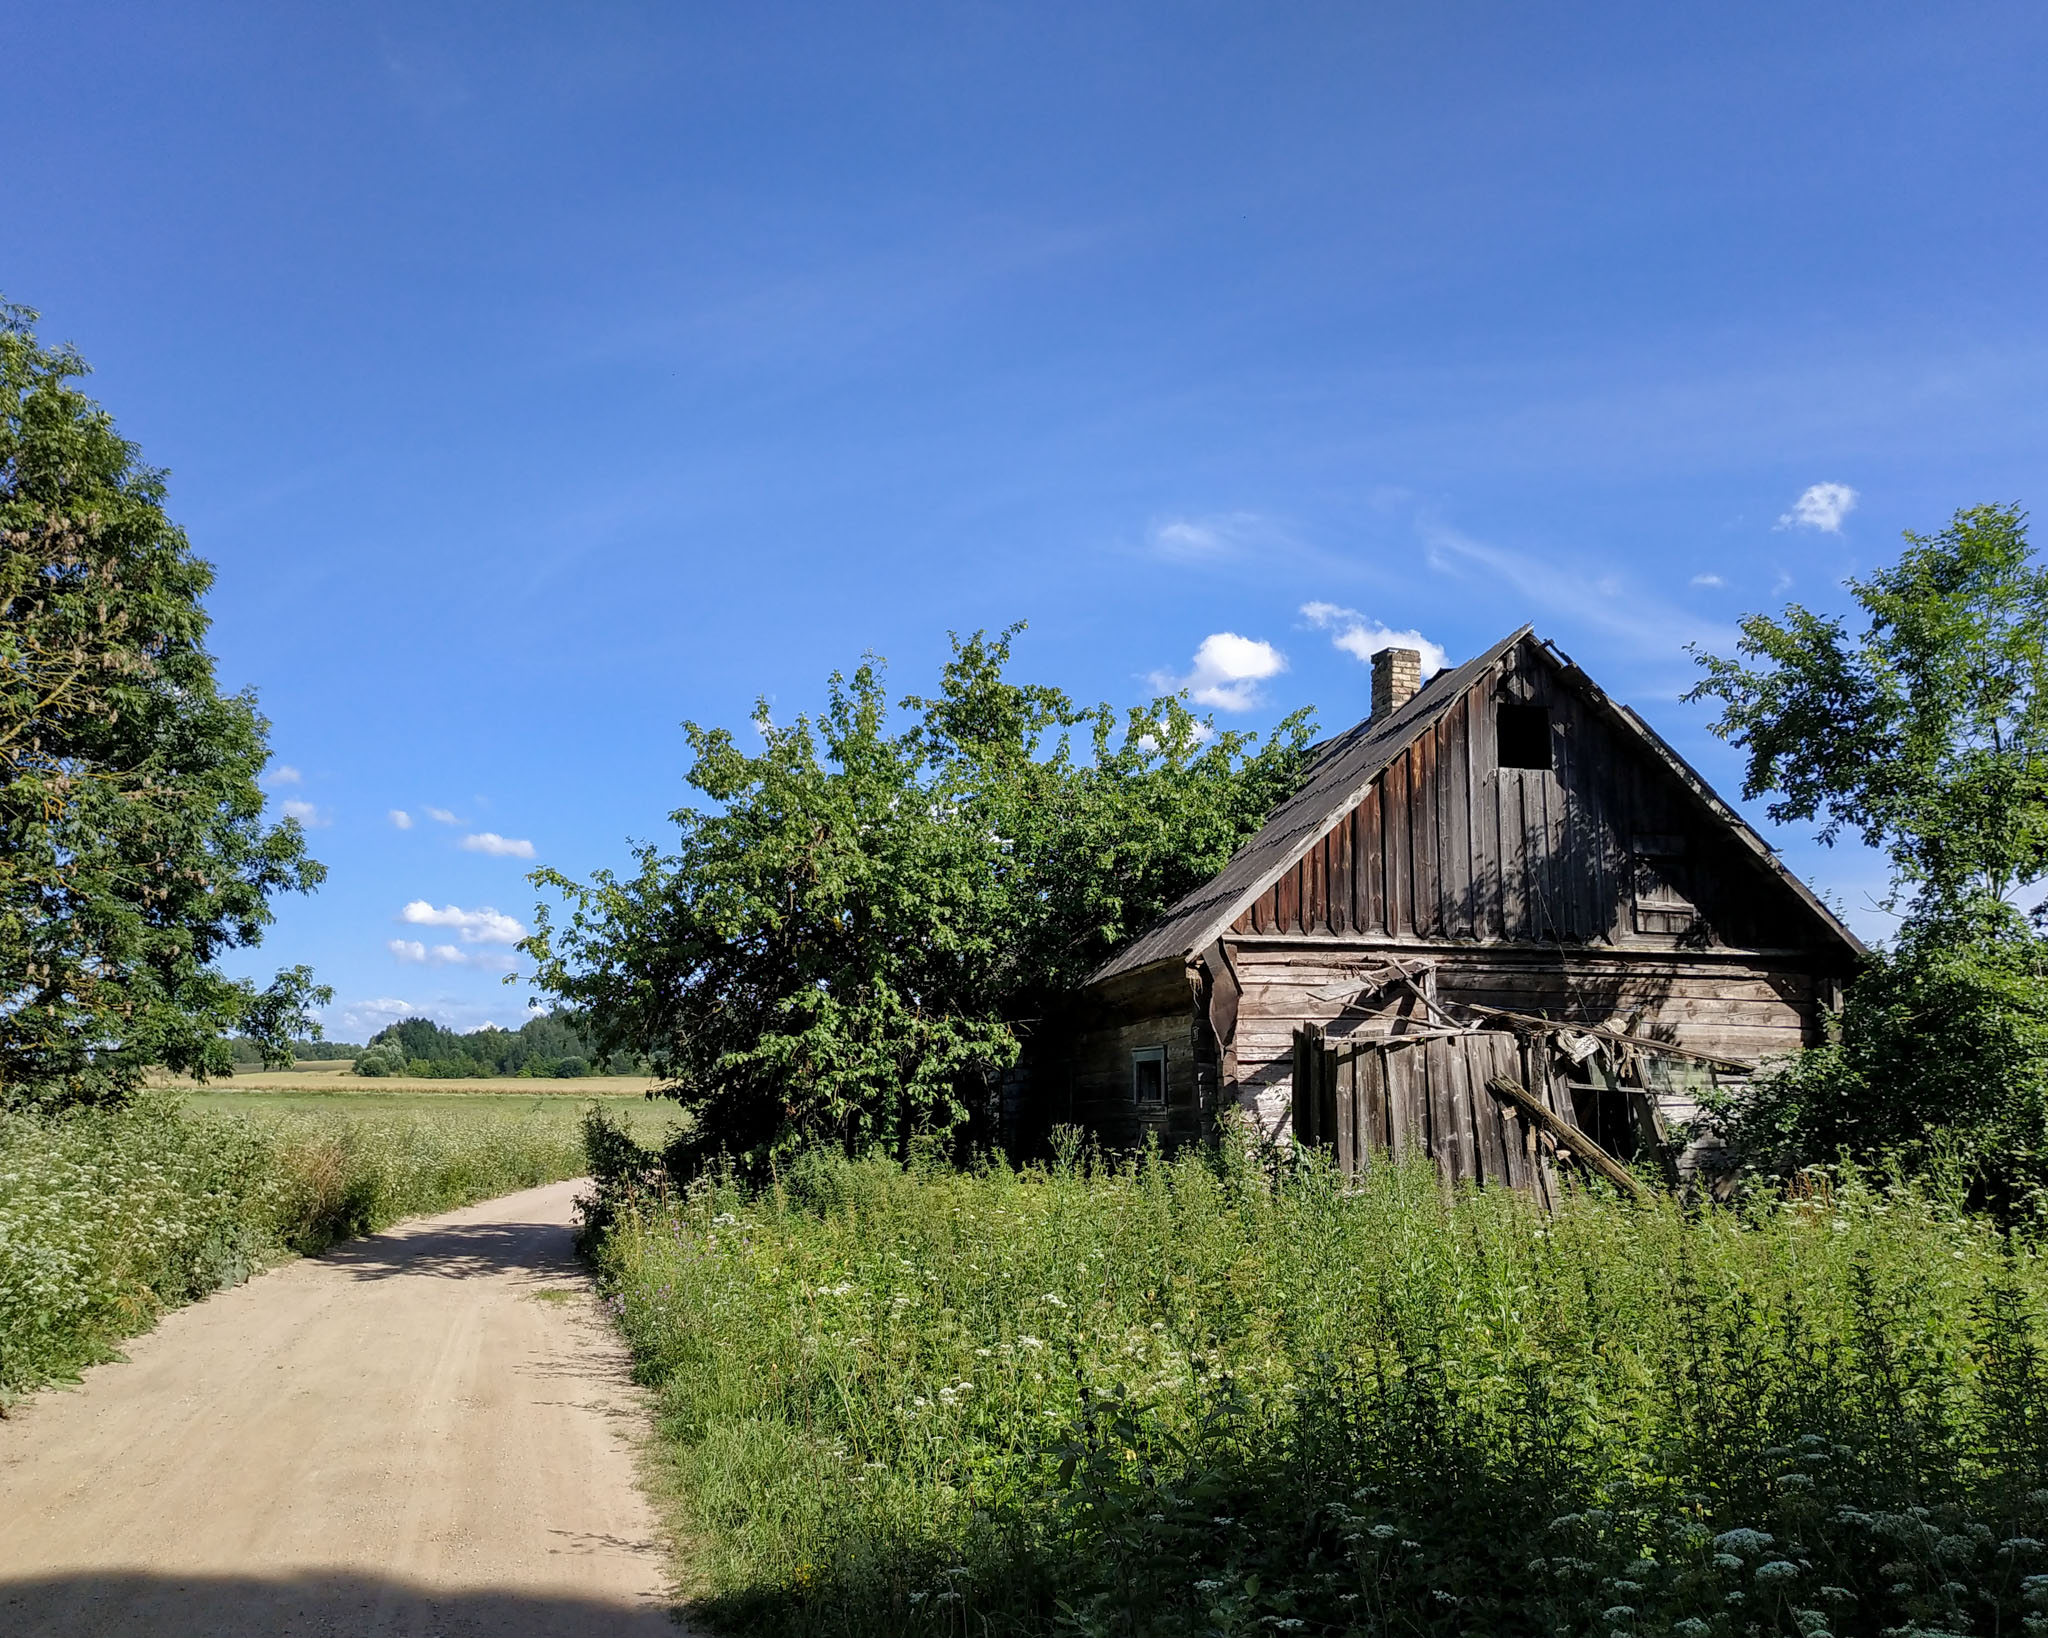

{"left": 1085, "top": 627, "right": 1864, "bottom": 985}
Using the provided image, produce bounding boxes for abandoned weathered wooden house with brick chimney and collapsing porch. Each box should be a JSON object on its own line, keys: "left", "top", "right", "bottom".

{"left": 1024, "top": 627, "right": 1864, "bottom": 1198}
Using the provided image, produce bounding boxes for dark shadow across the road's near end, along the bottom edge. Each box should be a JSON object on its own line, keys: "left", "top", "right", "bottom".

{"left": 0, "top": 1570, "right": 678, "bottom": 1638}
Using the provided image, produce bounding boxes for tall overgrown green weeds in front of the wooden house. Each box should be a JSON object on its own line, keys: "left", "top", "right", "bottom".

{"left": 592, "top": 1122, "right": 2048, "bottom": 1638}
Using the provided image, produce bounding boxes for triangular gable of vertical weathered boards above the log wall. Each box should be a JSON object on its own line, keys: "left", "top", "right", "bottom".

{"left": 1233, "top": 643, "right": 1817, "bottom": 948}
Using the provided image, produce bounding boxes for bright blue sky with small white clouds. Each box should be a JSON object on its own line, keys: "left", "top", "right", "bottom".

{"left": 0, "top": 0, "right": 2048, "bottom": 1040}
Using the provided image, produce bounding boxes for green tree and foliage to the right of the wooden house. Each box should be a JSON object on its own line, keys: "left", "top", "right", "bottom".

{"left": 1694, "top": 506, "right": 2048, "bottom": 1210}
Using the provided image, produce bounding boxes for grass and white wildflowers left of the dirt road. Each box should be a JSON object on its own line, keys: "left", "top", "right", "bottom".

{"left": 0, "top": 1093, "right": 622, "bottom": 1403}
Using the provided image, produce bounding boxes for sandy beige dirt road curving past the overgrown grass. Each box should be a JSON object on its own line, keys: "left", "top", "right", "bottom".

{"left": 0, "top": 1183, "right": 676, "bottom": 1638}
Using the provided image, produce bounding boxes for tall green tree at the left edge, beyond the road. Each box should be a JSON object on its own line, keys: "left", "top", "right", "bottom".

{"left": 0, "top": 305, "right": 328, "bottom": 1104}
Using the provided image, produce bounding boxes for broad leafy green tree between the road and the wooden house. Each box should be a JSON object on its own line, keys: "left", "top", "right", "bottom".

{"left": 522, "top": 627, "right": 1309, "bottom": 1157}
